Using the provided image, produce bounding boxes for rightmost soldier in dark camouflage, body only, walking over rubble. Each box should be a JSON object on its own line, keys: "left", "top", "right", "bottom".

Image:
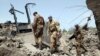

{"left": 69, "top": 25, "right": 87, "bottom": 56}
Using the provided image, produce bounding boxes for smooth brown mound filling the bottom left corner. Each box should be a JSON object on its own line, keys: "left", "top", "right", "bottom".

{"left": 0, "top": 47, "right": 26, "bottom": 56}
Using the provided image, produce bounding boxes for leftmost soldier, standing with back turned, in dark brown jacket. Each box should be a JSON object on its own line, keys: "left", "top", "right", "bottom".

{"left": 33, "top": 12, "right": 45, "bottom": 49}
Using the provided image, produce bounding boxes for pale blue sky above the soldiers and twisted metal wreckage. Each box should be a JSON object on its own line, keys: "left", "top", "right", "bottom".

{"left": 0, "top": 0, "right": 95, "bottom": 30}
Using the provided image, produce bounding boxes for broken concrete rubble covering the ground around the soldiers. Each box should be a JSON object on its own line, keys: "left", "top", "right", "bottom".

{"left": 0, "top": 30, "right": 100, "bottom": 56}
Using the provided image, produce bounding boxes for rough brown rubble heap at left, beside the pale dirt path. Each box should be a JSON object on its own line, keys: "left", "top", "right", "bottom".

{"left": 0, "top": 31, "right": 26, "bottom": 56}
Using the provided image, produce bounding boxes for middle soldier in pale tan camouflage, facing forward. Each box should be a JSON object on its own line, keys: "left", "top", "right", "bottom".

{"left": 48, "top": 16, "right": 59, "bottom": 53}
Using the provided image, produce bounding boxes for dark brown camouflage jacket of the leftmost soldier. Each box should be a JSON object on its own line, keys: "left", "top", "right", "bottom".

{"left": 33, "top": 15, "right": 45, "bottom": 35}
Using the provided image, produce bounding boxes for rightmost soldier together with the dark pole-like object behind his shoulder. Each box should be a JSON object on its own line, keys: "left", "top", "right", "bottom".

{"left": 69, "top": 17, "right": 91, "bottom": 56}
